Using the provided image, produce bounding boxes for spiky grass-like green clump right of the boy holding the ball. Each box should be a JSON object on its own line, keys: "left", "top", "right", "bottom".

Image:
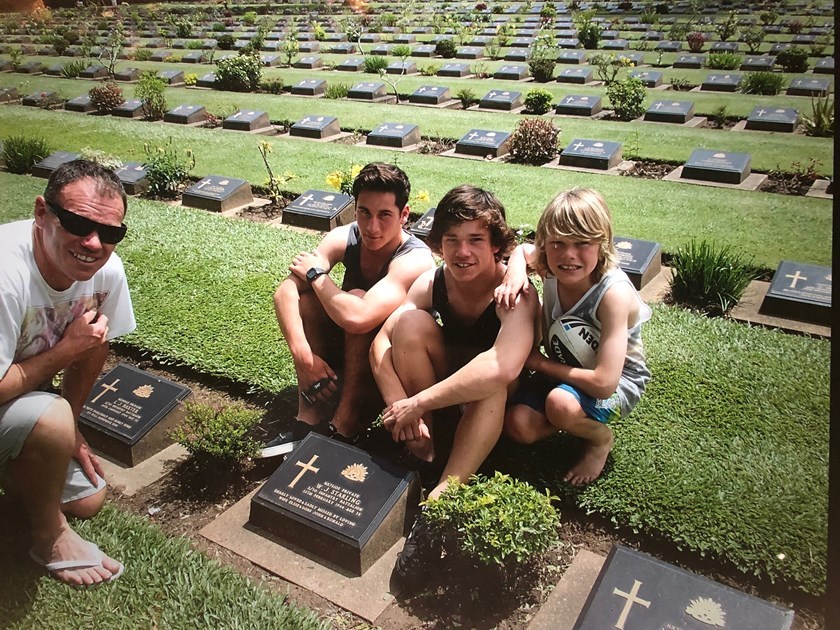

{"left": 670, "top": 239, "right": 757, "bottom": 315}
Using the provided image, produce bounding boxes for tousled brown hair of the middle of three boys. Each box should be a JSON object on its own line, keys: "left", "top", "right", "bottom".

{"left": 426, "top": 184, "right": 516, "bottom": 260}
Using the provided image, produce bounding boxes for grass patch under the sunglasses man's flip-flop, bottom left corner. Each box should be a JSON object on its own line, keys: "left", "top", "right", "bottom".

{"left": 0, "top": 505, "right": 327, "bottom": 630}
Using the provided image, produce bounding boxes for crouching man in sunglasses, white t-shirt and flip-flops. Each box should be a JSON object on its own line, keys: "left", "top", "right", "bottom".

{"left": 0, "top": 160, "right": 135, "bottom": 586}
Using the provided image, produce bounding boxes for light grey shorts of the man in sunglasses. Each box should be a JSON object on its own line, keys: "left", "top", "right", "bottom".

{"left": 0, "top": 392, "right": 105, "bottom": 503}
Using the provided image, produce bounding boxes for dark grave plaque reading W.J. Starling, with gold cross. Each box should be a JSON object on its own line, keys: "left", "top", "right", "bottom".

{"left": 249, "top": 433, "right": 420, "bottom": 575}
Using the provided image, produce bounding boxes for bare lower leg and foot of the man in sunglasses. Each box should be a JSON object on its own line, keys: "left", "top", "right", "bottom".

{"left": 9, "top": 398, "right": 120, "bottom": 586}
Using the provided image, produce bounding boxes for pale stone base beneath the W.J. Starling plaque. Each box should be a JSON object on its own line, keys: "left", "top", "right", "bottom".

{"left": 200, "top": 489, "right": 404, "bottom": 623}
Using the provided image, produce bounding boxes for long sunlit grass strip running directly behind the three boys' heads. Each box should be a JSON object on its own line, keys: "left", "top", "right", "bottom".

{"left": 0, "top": 107, "right": 831, "bottom": 268}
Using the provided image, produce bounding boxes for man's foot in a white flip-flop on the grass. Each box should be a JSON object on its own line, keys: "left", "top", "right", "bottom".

{"left": 30, "top": 525, "right": 123, "bottom": 586}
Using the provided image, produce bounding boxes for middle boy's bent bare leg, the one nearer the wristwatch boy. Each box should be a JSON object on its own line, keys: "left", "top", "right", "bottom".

{"left": 391, "top": 311, "right": 447, "bottom": 462}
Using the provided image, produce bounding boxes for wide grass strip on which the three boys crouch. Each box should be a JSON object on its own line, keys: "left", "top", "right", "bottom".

{"left": 0, "top": 174, "right": 830, "bottom": 592}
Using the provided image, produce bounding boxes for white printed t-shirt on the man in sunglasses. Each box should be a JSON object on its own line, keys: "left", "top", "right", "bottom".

{"left": 0, "top": 219, "right": 137, "bottom": 378}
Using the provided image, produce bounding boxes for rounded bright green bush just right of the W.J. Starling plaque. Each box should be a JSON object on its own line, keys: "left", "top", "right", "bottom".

{"left": 426, "top": 472, "right": 560, "bottom": 566}
